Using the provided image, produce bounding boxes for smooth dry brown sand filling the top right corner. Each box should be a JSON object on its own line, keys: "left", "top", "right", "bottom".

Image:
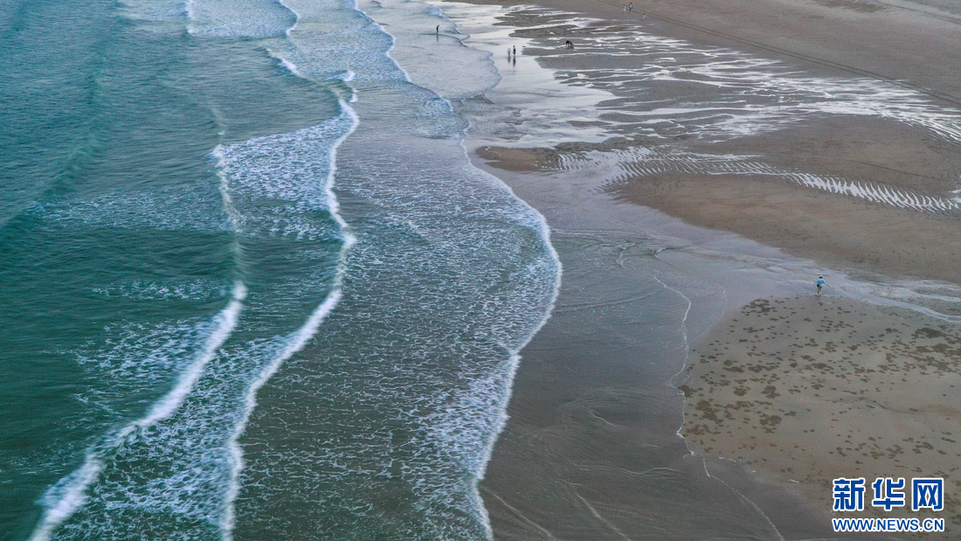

{"left": 488, "top": 0, "right": 961, "bottom": 105}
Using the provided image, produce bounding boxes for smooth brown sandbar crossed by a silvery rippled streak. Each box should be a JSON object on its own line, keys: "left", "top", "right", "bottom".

{"left": 610, "top": 116, "right": 961, "bottom": 284}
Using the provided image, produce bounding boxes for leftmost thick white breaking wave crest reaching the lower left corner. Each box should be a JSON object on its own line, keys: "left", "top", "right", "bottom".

{"left": 29, "top": 281, "right": 247, "bottom": 541}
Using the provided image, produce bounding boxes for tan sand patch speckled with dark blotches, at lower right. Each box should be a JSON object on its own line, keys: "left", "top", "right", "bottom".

{"left": 680, "top": 295, "right": 961, "bottom": 539}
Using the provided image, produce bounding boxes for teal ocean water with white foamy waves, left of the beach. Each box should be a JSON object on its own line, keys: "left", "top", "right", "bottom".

{"left": 0, "top": 0, "right": 560, "bottom": 541}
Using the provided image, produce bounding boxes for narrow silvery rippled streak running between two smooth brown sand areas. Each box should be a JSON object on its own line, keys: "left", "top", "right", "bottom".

{"left": 551, "top": 148, "right": 961, "bottom": 212}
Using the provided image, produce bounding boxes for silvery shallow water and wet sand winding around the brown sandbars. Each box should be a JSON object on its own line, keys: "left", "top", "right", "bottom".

{"left": 441, "top": 3, "right": 961, "bottom": 539}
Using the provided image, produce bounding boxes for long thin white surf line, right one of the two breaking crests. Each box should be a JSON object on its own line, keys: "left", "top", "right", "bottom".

{"left": 219, "top": 98, "right": 360, "bottom": 541}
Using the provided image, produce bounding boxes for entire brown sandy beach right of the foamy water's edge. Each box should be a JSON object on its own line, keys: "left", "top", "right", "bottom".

{"left": 455, "top": 0, "right": 961, "bottom": 540}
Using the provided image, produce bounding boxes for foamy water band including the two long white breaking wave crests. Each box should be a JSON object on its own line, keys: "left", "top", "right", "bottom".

{"left": 32, "top": 99, "right": 358, "bottom": 541}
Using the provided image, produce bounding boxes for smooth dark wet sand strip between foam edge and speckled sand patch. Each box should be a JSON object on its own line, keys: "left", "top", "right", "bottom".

{"left": 472, "top": 162, "right": 831, "bottom": 541}
